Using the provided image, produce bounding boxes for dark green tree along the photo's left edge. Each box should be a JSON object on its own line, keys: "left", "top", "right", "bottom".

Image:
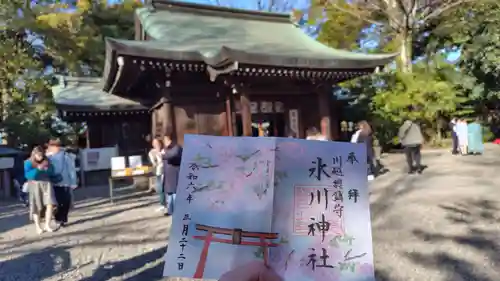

{"left": 0, "top": 1, "right": 51, "bottom": 147}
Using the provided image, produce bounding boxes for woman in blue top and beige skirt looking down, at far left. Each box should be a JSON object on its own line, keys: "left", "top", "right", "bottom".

{"left": 24, "top": 146, "right": 57, "bottom": 234}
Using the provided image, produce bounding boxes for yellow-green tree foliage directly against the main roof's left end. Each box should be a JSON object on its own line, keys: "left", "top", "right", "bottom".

{"left": 32, "top": 0, "right": 142, "bottom": 77}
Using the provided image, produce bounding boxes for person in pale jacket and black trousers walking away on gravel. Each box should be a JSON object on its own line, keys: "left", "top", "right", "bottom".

{"left": 398, "top": 117, "right": 424, "bottom": 174}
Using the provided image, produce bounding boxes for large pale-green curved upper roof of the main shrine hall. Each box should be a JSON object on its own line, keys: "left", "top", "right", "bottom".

{"left": 108, "top": 0, "right": 395, "bottom": 70}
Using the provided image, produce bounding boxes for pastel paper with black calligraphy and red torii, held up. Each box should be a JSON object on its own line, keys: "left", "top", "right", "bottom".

{"left": 164, "top": 135, "right": 375, "bottom": 281}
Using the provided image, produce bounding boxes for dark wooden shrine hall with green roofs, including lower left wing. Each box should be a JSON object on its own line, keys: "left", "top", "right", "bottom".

{"left": 53, "top": 0, "right": 395, "bottom": 155}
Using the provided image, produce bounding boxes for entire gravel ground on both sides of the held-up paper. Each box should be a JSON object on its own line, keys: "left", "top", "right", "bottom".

{"left": 0, "top": 146, "right": 500, "bottom": 281}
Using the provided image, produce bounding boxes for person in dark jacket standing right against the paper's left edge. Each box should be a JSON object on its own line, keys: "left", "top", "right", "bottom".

{"left": 162, "top": 135, "right": 182, "bottom": 216}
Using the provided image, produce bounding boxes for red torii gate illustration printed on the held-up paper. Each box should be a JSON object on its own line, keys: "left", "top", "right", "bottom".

{"left": 193, "top": 224, "right": 279, "bottom": 279}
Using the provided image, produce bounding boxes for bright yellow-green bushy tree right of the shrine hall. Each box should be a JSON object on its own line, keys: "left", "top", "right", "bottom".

{"left": 370, "top": 55, "right": 471, "bottom": 142}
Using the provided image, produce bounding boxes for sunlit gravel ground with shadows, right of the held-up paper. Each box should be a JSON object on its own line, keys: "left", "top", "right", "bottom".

{"left": 371, "top": 146, "right": 500, "bottom": 281}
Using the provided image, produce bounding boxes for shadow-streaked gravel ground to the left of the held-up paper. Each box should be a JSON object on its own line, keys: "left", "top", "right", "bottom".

{"left": 0, "top": 187, "right": 170, "bottom": 281}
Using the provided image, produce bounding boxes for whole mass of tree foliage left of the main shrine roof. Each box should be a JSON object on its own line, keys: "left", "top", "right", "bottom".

{"left": 0, "top": 0, "right": 142, "bottom": 146}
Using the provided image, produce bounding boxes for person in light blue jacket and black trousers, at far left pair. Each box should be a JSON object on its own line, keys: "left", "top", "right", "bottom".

{"left": 47, "top": 139, "right": 78, "bottom": 227}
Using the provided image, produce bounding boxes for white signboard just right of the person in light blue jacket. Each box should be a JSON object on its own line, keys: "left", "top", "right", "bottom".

{"left": 80, "top": 147, "right": 118, "bottom": 172}
